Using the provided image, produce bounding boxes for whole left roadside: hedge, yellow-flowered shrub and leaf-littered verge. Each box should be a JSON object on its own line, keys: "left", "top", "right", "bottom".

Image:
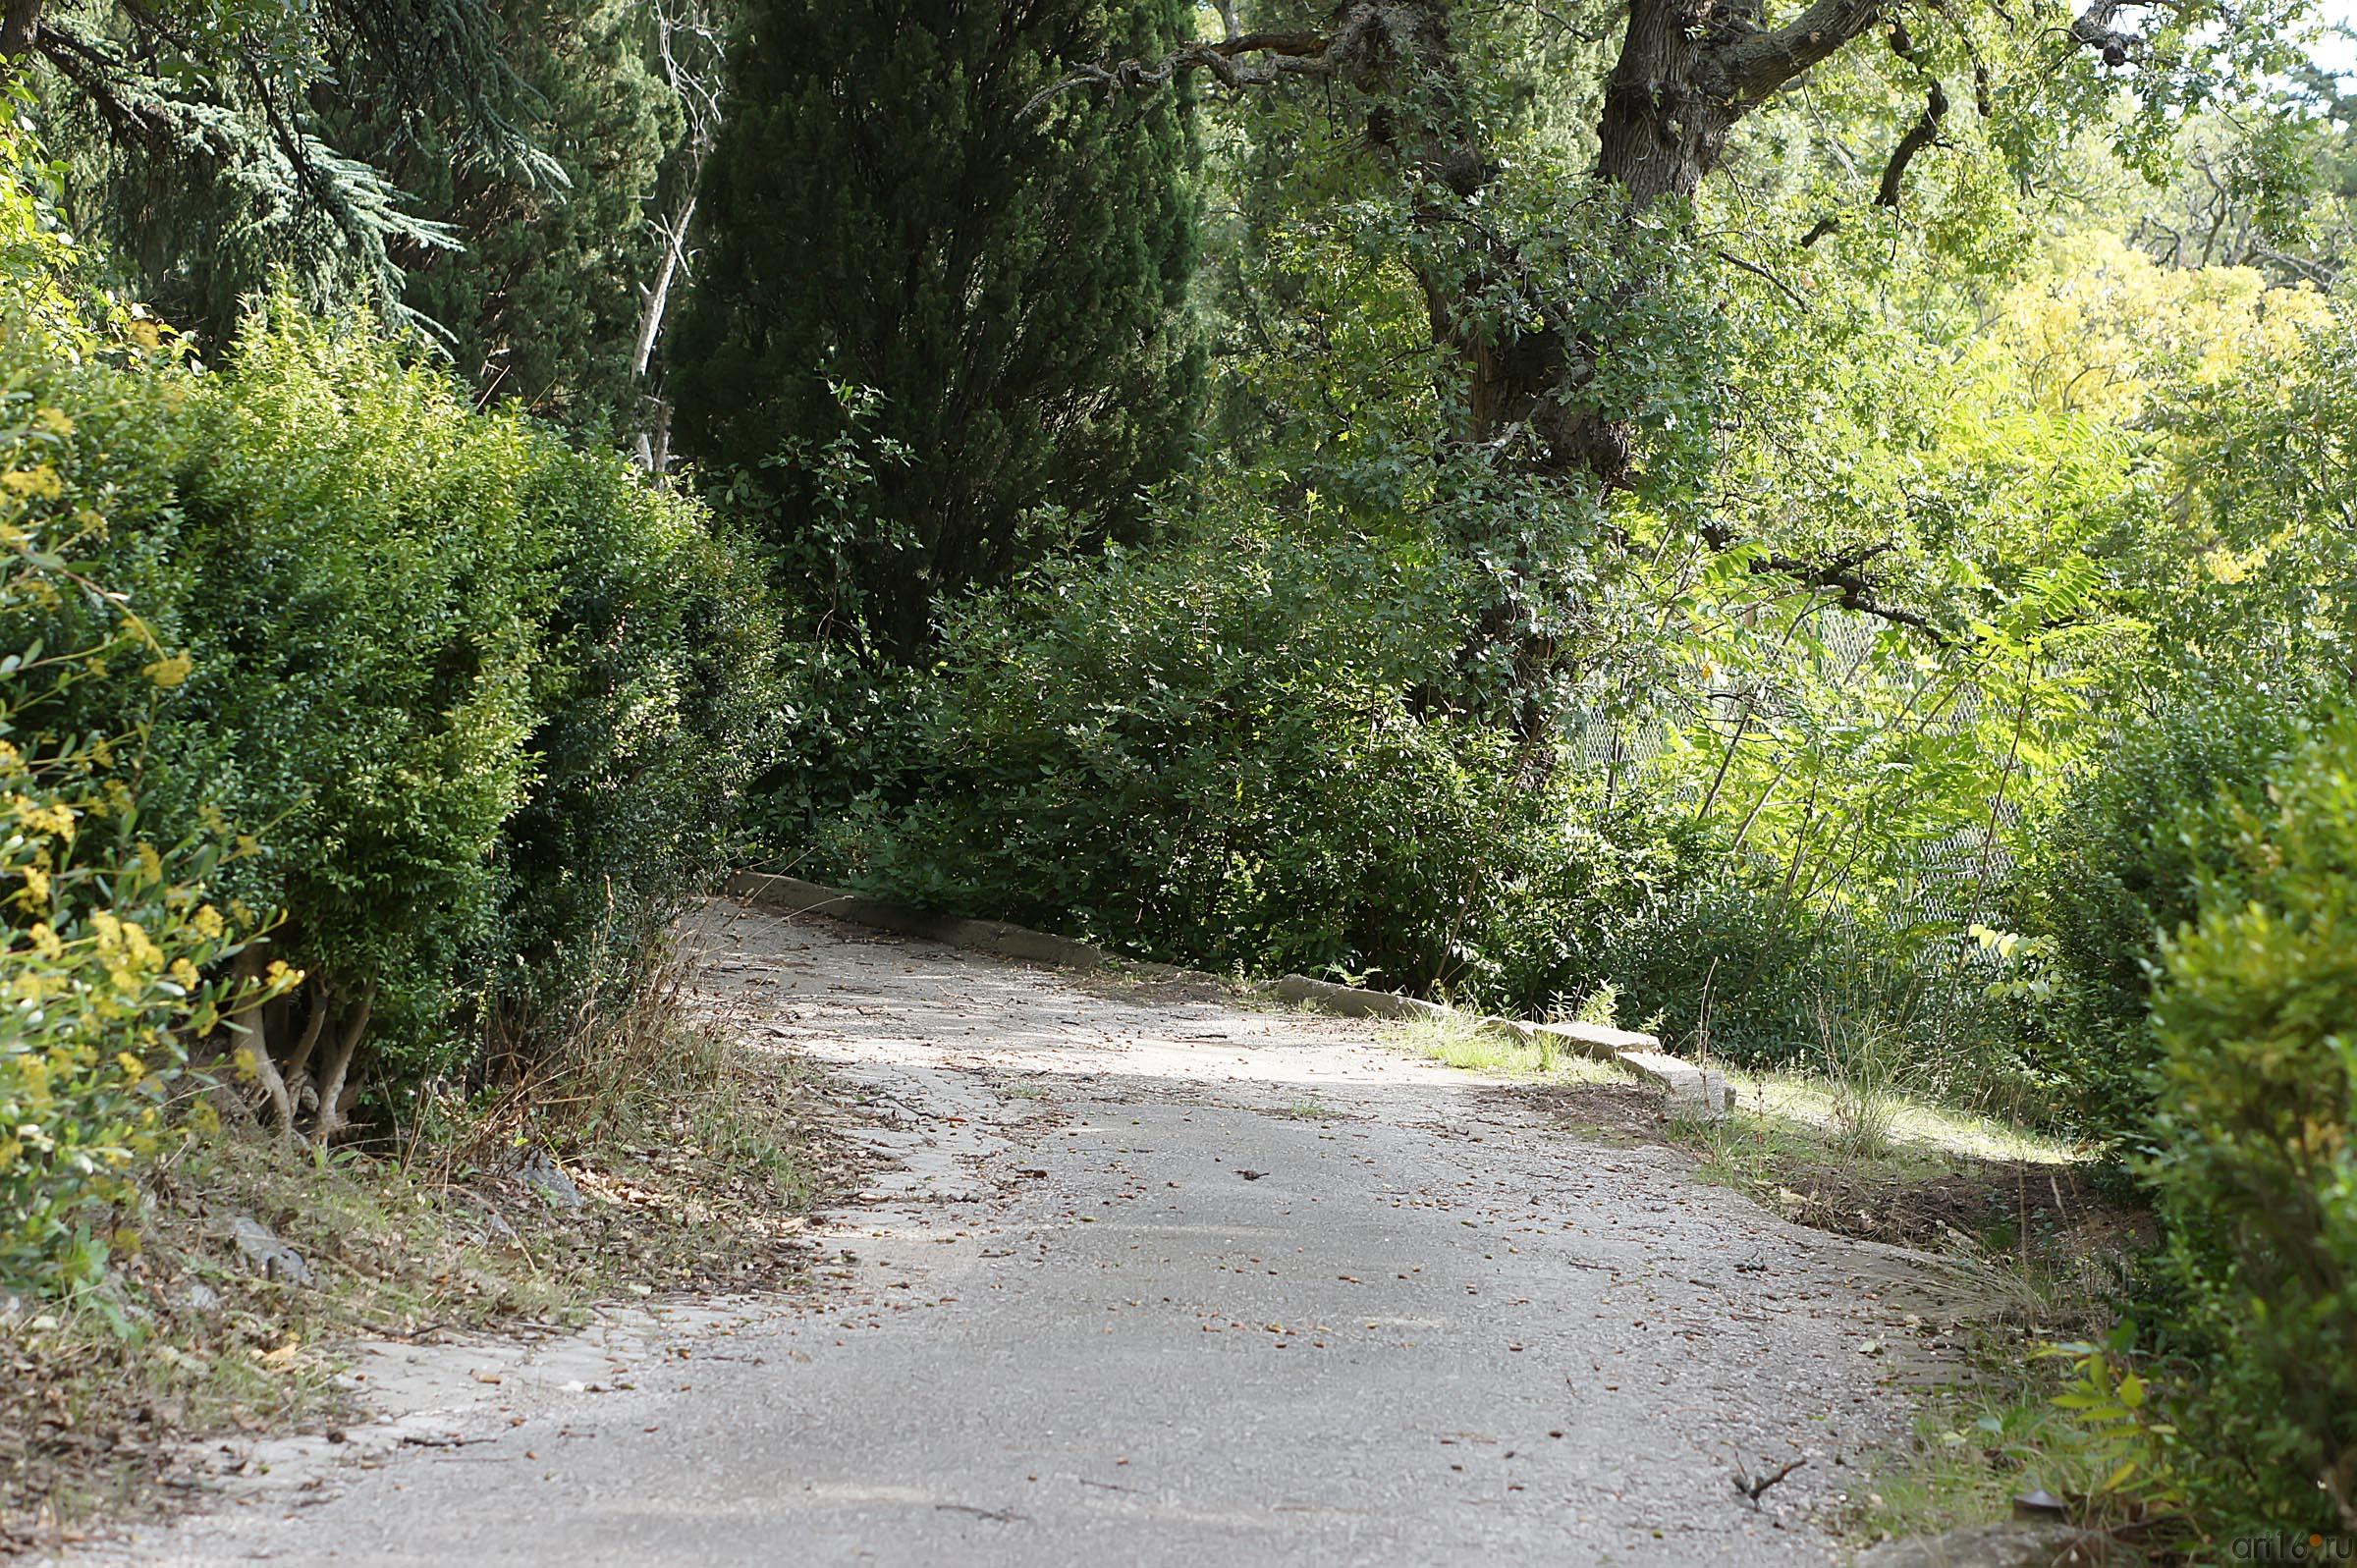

{"left": 0, "top": 94, "right": 823, "bottom": 1546}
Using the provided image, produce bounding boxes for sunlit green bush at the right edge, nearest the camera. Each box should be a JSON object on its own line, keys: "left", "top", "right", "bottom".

{"left": 2147, "top": 722, "right": 2357, "bottom": 1533}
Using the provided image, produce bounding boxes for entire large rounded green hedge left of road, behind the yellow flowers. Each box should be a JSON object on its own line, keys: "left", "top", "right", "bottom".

{"left": 158, "top": 313, "right": 792, "bottom": 1127}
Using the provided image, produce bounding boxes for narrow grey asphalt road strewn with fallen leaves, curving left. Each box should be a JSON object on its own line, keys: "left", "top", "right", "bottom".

{"left": 82, "top": 903, "right": 1951, "bottom": 1568}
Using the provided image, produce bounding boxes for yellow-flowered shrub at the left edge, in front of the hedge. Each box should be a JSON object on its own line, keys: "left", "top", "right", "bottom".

{"left": 0, "top": 333, "right": 281, "bottom": 1292}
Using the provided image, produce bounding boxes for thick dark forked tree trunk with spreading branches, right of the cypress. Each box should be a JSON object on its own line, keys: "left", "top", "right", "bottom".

{"left": 1061, "top": 0, "right": 1886, "bottom": 735}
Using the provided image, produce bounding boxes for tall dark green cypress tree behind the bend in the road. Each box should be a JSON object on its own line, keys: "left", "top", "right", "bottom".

{"left": 667, "top": 0, "right": 1202, "bottom": 656}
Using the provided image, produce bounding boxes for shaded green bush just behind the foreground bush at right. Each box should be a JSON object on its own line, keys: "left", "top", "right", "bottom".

{"left": 2015, "top": 688, "right": 2303, "bottom": 1139}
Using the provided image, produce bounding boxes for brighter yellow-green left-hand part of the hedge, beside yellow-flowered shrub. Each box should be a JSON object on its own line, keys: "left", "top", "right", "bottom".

{"left": 158, "top": 309, "right": 547, "bottom": 1075}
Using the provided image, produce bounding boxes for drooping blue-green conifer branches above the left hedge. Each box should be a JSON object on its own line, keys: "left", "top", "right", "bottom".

{"left": 28, "top": 0, "right": 564, "bottom": 347}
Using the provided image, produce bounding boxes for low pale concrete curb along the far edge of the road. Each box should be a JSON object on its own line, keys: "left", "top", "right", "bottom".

{"left": 724, "top": 870, "right": 1734, "bottom": 1120}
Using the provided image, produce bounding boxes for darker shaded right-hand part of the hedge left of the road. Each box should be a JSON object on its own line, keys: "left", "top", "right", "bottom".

{"left": 481, "top": 436, "right": 785, "bottom": 1054}
